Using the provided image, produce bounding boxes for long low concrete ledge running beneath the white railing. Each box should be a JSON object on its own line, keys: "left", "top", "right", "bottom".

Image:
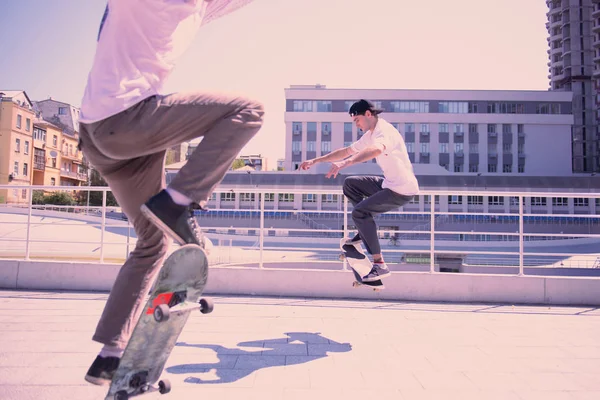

{"left": 0, "top": 260, "right": 600, "bottom": 306}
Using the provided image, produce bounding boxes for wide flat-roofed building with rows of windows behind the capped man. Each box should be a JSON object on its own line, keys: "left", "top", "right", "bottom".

{"left": 285, "top": 85, "right": 573, "bottom": 176}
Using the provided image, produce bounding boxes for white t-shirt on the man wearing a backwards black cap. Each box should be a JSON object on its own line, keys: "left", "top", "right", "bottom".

{"left": 351, "top": 117, "right": 419, "bottom": 196}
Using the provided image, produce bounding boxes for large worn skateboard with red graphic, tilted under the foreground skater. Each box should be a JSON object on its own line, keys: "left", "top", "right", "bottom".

{"left": 106, "top": 244, "right": 214, "bottom": 400}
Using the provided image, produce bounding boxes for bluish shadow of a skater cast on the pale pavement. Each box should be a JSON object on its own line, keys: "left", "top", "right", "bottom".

{"left": 166, "top": 332, "right": 352, "bottom": 384}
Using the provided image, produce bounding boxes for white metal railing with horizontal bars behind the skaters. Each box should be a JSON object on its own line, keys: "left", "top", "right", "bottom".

{"left": 0, "top": 185, "right": 600, "bottom": 275}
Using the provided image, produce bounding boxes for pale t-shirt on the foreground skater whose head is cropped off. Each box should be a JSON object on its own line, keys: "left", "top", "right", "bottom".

{"left": 80, "top": 0, "right": 252, "bottom": 123}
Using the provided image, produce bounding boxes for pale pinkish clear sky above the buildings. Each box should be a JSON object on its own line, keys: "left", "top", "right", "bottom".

{"left": 0, "top": 0, "right": 548, "bottom": 167}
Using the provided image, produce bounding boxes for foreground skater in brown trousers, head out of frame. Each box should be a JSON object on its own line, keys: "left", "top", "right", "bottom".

{"left": 79, "top": 0, "right": 264, "bottom": 385}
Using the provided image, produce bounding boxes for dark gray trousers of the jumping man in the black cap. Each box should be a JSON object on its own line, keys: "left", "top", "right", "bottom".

{"left": 344, "top": 176, "right": 413, "bottom": 254}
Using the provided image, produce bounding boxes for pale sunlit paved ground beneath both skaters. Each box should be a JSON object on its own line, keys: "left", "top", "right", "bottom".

{"left": 0, "top": 291, "right": 600, "bottom": 400}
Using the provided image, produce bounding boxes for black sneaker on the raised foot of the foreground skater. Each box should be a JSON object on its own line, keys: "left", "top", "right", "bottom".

{"left": 141, "top": 189, "right": 205, "bottom": 248}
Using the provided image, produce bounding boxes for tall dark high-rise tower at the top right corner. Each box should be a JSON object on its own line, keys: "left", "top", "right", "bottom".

{"left": 546, "top": 0, "right": 600, "bottom": 173}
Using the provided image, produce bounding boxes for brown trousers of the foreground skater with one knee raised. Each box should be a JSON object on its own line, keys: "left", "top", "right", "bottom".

{"left": 80, "top": 90, "right": 263, "bottom": 348}
